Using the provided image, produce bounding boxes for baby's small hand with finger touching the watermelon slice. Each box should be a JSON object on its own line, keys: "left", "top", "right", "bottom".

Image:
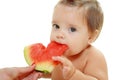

{"left": 52, "top": 56, "right": 75, "bottom": 80}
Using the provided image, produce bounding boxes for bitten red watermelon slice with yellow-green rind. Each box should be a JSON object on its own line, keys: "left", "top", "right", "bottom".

{"left": 24, "top": 41, "right": 68, "bottom": 73}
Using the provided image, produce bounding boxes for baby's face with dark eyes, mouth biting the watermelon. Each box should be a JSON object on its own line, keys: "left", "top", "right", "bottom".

{"left": 50, "top": 4, "right": 90, "bottom": 56}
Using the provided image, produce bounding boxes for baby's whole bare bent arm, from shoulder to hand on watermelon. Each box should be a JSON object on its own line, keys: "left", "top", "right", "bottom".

{"left": 53, "top": 52, "right": 108, "bottom": 80}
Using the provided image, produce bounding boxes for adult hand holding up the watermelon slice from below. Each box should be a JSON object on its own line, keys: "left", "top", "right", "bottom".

{"left": 0, "top": 65, "right": 42, "bottom": 80}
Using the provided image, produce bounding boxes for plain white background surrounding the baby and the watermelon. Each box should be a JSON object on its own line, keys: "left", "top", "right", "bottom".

{"left": 0, "top": 0, "right": 120, "bottom": 80}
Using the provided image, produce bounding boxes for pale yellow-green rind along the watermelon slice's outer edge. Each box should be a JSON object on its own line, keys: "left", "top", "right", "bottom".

{"left": 24, "top": 46, "right": 55, "bottom": 73}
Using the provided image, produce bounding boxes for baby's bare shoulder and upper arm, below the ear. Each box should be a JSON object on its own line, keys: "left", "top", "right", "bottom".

{"left": 84, "top": 46, "right": 107, "bottom": 80}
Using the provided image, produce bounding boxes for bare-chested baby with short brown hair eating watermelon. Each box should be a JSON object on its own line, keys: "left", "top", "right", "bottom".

{"left": 47, "top": 0, "right": 108, "bottom": 80}
